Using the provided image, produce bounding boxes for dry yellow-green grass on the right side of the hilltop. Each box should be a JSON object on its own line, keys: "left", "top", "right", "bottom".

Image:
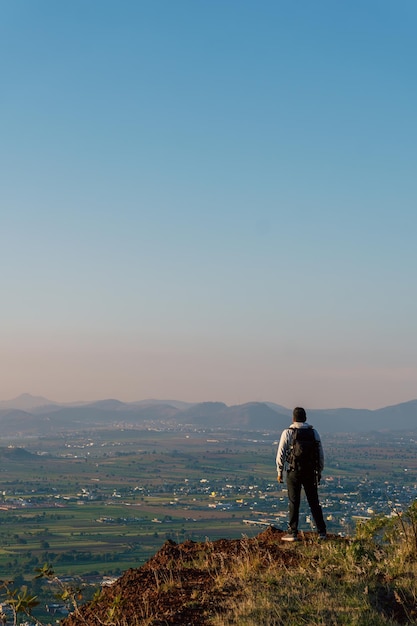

{"left": 210, "top": 504, "right": 417, "bottom": 626}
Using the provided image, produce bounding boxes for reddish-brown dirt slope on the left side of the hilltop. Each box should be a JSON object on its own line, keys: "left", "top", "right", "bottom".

{"left": 61, "top": 527, "right": 322, "bottom": 626}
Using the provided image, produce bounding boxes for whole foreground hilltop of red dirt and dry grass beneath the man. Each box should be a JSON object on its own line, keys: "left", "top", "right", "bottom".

{"left": 62, "top": 520, "right": 417, "bottom": 626}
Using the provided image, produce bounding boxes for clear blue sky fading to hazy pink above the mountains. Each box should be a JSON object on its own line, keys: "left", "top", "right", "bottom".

{"left": 0, "top": 0, "right": 417, "bottom": 408}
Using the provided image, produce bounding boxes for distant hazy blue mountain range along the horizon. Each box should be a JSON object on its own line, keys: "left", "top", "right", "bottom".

{"left": 0, "top": 393, "right": 417, "bottom": 437}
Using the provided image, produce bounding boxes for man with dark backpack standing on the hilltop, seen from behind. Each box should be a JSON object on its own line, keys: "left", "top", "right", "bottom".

{"left": 276, "top": 406, "right": 326, "bottom": 541}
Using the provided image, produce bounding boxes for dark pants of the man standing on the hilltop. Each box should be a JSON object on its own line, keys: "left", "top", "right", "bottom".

{"left": 287, "top": 470, "right": 326, "bottom": 534}
